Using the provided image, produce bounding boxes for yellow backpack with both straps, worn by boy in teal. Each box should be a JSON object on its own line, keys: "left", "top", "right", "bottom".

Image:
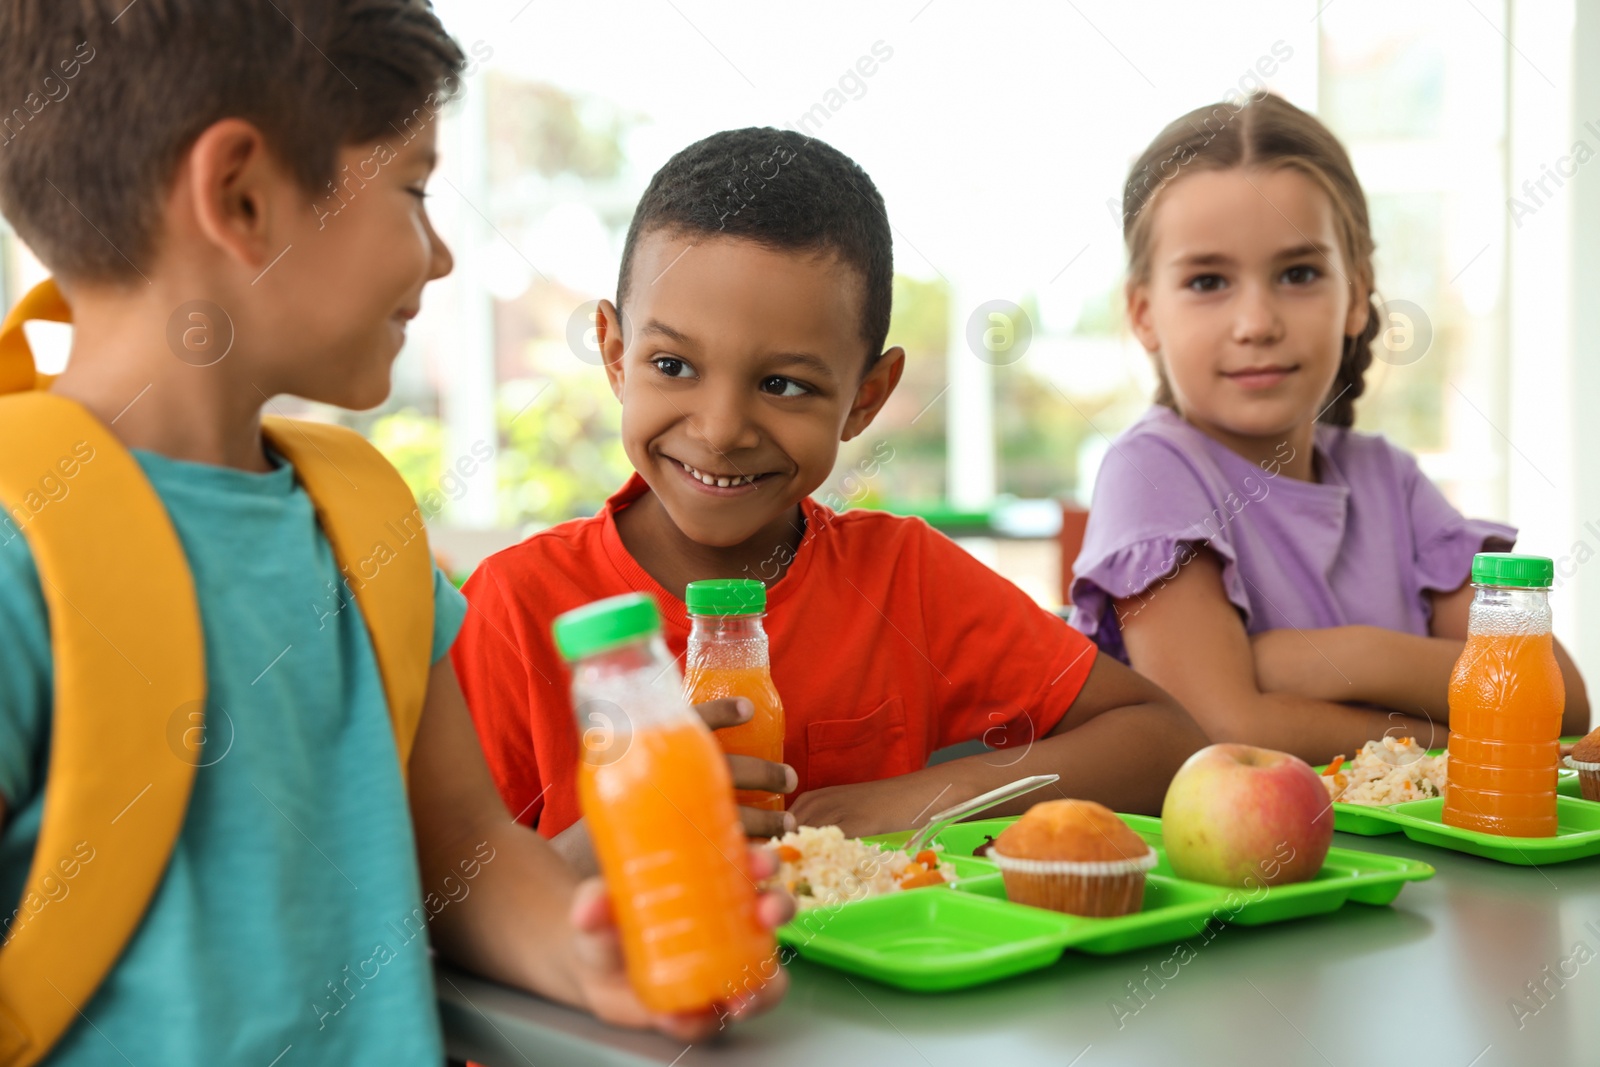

{"left": 0, "top": 282, "right": 434, "bottom": 1067}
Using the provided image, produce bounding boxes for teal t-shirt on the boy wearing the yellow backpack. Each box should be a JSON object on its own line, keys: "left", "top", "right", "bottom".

{"left": 0, "top": 453, "right": 466, "bottom": 1067}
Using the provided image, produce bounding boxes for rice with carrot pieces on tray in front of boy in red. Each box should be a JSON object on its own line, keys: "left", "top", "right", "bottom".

{"left": 771, "top": 825, "right": 955, "bottom": 912}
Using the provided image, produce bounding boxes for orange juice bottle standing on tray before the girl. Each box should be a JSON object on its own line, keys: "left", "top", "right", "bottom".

{"left": 1443, "top": 552, "right": 1566, "bottom": 837}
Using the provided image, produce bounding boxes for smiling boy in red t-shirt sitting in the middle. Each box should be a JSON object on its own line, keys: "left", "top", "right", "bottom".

{"left": 454, "top": 130, "right": 1205, "bottom": 859}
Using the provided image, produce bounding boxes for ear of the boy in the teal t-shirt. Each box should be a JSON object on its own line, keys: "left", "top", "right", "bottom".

{"left": 173, "top": 118, "right": 294, "bottom": 270}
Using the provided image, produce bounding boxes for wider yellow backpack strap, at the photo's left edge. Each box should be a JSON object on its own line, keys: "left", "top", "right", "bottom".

{"left": 0, "top": 395, "right": 205, "bottom": 1067}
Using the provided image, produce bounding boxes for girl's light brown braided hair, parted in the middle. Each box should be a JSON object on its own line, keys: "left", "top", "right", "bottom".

{"left": 1122, "top": 93, "right": 1382, "bottom": 426}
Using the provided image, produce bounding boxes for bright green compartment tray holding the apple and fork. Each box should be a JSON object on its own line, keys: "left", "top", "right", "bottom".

{"left": 778, "top": 816, "right": 1434, "bottom": 992}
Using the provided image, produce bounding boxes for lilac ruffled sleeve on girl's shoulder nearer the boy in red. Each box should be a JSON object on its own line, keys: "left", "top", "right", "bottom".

{"left": 1070, "top": 432, "right": 1264, "bottom": 662}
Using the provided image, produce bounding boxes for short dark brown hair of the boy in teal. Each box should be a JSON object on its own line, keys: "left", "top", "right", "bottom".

{"left": 0, "top": 0, "right": 466, "bottom": 283}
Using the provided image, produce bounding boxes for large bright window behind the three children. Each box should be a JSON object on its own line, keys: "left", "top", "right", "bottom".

{"left": 0, "top": 0, "right": 1561, "bottom": 614}
